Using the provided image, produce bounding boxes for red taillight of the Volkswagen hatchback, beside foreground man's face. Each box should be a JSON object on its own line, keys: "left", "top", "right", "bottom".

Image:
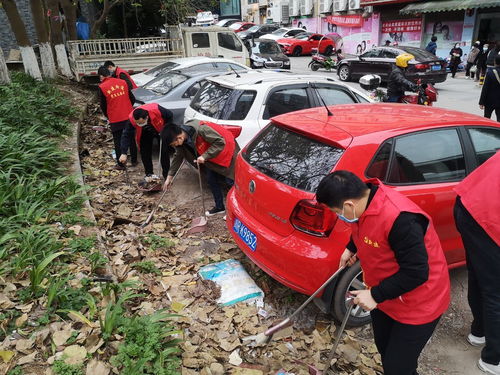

{"left": 290, "top": 199, "right": 336, "bottom": 237}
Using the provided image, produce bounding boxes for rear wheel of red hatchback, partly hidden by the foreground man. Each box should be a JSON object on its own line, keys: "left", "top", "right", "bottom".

{"left": 332, "top": 262, "right": 371, "bottom": 327}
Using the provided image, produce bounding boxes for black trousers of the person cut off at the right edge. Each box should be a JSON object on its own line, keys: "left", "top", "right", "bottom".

{"left": 453, "top": 198, "right": 500, "bottom": 365}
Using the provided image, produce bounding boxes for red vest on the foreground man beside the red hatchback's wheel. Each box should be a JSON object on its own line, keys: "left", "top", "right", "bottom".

{"left": 352, "top": 179, "right": 450, "bottom": 325}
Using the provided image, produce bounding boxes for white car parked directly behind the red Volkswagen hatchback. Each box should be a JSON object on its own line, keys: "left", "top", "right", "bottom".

{"left": 184, "top": 70, "right": 372, "bottom": 147}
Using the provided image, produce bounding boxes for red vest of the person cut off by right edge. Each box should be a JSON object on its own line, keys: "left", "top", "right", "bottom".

{"left": 454, "top": 152, "right": 500, "bottom": 246}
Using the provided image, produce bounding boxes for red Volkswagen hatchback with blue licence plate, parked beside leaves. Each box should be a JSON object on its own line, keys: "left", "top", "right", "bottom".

{"left": 227, "top": 103, "right": 500, "bottom": 326}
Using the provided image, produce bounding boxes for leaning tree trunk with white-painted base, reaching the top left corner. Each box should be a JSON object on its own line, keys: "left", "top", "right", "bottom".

{"left": 1, "top": 0, "right": 42, "bottom": 80}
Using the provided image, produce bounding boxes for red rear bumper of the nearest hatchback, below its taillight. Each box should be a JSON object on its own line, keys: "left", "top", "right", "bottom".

{"left": 226, "top": 188, "right": 349, "bottom": 295}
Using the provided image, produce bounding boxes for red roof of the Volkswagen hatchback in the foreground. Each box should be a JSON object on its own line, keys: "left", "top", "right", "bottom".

{"left": 272, "top": 103, "right": 499, "bottom": 147}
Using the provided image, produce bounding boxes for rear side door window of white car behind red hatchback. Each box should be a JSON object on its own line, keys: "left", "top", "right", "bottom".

{"left": 264, "top": 88, "right": 310, "bottom": 120}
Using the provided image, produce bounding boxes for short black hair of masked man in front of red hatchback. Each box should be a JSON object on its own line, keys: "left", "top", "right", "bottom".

{"left": 316, "top": 171, "right": 368, "bottom": 208}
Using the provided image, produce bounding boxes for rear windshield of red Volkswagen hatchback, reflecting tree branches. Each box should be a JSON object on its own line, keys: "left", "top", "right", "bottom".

{"left": 243, "top": 123, "right": 343, "bottom": 193}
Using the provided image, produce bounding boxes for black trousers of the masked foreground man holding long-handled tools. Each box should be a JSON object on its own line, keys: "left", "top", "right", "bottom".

{"left": 370, "top": 309, "right": 439, "bottom": 375}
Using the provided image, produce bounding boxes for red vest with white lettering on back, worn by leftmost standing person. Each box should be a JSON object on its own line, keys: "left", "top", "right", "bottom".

{"left": 99, "top": 77, "right": 133, "bottom": 123}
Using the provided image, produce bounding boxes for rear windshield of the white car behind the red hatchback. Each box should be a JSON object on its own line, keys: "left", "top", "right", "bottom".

{"left": 190, "top": 82, "right": 257, "bottom": 120}
